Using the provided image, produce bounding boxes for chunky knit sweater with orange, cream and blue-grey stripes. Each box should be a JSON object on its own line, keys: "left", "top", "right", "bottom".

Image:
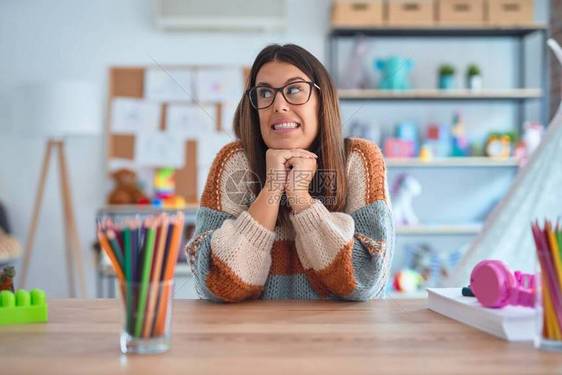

{"left": 186, "top": 138, "right": 394, "bottom": 302}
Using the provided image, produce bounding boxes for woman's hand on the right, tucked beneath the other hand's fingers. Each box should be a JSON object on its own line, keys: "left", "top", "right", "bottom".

{"left": 285, "top": 157, "right": 317, "bottom": 212}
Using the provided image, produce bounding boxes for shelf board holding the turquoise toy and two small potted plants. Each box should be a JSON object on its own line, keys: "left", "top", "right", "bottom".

{"left": 338, "top": 88, "right": 543, "bottom": 101}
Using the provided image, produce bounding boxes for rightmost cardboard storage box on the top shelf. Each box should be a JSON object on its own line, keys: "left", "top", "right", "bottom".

{"left": 487, "top": 0, "right": 534, "bottom": 26}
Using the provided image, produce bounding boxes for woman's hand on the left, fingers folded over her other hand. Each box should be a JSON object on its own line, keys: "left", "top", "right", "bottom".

{"left": 265, "top": 148, "right": 318, "bottom": 192}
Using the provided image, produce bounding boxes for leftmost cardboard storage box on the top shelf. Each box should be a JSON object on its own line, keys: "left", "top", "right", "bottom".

{"left": 332, "top": 0, "right": 383, "bottom": 27}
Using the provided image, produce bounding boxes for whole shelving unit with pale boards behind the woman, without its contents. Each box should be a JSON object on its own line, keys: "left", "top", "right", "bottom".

{"left": 328, "top": 24, "right": 549, "bottom": 298}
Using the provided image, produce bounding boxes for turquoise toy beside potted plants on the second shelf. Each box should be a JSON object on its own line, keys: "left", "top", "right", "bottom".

{"left": 374, "top": 56, "right": 414, "bottom": 90}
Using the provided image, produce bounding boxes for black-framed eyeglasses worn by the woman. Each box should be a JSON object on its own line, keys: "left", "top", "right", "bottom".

{"left": 247, "top": 81, "right": 320, "bottom": 109}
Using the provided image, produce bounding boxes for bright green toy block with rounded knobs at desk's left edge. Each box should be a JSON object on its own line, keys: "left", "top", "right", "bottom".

{"left": 0, "top": 289, "right": 49, "bottom": 325}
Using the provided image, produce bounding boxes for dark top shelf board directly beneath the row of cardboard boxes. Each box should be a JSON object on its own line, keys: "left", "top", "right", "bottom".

{"left": 330, "top": 23, "right": 548, "bottom": 37}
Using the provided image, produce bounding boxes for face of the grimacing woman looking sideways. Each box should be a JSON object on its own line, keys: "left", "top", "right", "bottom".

{"left": 256, "top": 61, "right": 319, "bottom": 149}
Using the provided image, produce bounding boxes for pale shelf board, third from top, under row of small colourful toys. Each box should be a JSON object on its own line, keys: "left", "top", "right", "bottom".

{"left": 385, "top": 156, "right": 518, "bottom": 168}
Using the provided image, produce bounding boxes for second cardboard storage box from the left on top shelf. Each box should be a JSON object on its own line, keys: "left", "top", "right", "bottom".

{"left": 386, "top": 0, "right": 435, "bottom": 26}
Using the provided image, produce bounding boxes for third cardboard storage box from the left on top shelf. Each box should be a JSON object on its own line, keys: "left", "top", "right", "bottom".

{"left": 437, "top": 0, "right": 485, "bottom": 26}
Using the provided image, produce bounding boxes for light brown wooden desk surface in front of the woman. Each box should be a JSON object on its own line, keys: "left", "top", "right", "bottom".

{"left": 0, "top": 300, "right": 562, "bottom": 375}
